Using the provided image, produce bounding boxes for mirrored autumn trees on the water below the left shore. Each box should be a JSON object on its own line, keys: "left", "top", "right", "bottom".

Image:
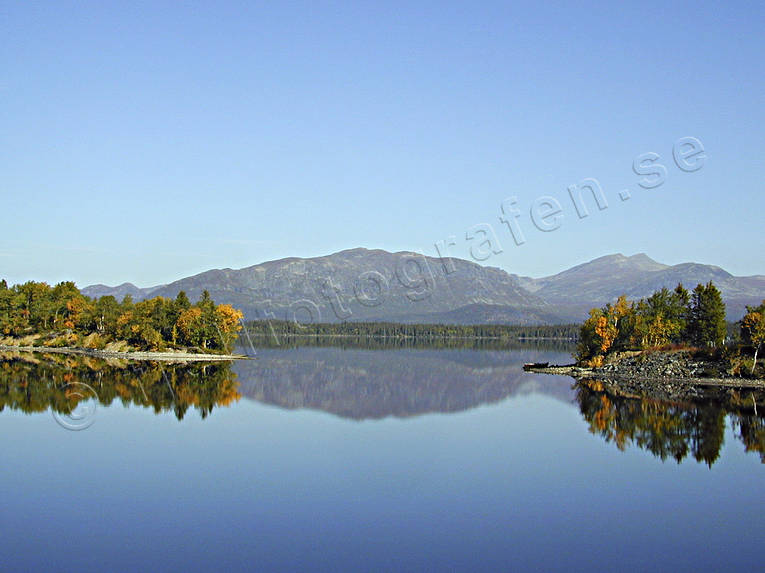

{"left": 0, "top": 354, "right": 240, "bottom": 420}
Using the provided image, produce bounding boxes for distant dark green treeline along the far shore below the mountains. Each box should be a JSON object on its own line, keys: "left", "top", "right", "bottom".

{"left": 247, "top": 320, "right": 580, "bottom": 344}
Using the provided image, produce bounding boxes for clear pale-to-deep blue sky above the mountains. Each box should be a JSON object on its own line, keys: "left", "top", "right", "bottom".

{"left": 0, "top": 1, "right": 765, "bottom": 286}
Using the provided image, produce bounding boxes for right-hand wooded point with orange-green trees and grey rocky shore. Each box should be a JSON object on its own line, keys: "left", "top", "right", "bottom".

{"left": 528, "top": 282, "right": 765, "bottom": 389}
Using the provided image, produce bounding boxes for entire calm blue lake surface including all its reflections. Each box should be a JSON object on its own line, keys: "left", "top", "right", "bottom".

{"left": 0, "top": 346, "right": 765, "bottom": 572}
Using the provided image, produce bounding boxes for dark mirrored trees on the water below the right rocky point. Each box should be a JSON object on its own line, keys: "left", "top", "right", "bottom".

{"left": 576, "top": 380, "right": 765, "bottom": 467}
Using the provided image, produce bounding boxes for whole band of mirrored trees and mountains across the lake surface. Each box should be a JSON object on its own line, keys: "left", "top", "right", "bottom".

{"left": 5, "top": 346, "right": 765, "bottom": 467}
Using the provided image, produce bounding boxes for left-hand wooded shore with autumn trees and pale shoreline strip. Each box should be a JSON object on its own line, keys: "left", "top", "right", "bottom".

{"left": 0, "top": 280, "right": 242, "bottom": 355}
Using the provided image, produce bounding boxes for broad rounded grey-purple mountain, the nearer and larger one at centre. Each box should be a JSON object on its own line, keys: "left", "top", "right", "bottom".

{"left": 89, "top": 249, "right": 557, "bottom": 323}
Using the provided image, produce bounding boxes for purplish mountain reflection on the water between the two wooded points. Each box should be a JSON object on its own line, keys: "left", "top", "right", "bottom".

{"left": 234, "top": 346, "right": 574, "bottom": 420}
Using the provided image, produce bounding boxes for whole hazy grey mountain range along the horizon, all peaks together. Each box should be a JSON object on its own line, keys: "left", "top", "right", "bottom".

{"left": 82, "top": 248, "right": 765, "bottom": 324}
